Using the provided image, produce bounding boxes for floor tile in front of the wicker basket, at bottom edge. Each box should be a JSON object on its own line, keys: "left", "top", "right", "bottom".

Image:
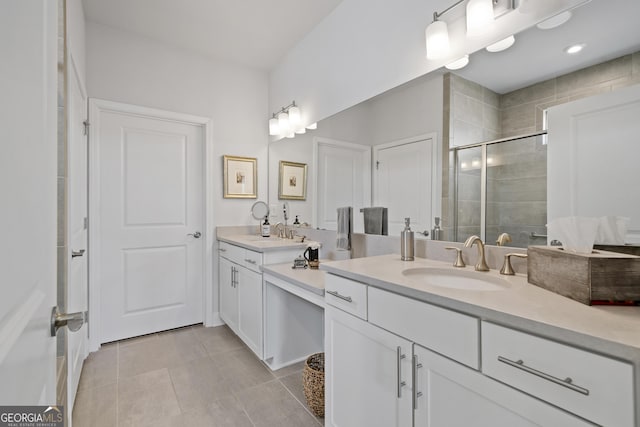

{"left": 237, "top": 380, "right": 318, "bottom": 427}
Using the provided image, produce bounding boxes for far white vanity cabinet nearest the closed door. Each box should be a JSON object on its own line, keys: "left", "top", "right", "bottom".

{"left": 218, "top": 241, "right": 302, "bottom": 360}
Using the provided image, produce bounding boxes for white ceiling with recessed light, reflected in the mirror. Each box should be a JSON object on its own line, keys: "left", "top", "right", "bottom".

{"left": 455, "top": 0, "right": 640, "bottom": 93}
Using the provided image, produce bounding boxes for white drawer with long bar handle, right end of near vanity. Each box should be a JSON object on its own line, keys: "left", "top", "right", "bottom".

{"left": 482, "top": 322, "right": 634, "bottom": 427}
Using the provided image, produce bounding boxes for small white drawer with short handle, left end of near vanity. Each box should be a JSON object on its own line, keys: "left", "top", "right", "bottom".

{"left": 324, "top": 274, "right": 367, "bottom": 320}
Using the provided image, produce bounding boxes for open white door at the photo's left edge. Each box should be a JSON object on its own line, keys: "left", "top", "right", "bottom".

{"left": 0, "top": 0, "right": 58, "bottom": 408}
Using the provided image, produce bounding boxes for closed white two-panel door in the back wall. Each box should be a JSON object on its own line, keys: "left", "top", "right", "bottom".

{"left": 96, "top": 103, "right": 204, "bottom": 342}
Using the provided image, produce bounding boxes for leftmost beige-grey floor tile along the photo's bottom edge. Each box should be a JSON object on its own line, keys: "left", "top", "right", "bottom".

{"left": 73, "top": 384, "right": 117, "bottom": 427}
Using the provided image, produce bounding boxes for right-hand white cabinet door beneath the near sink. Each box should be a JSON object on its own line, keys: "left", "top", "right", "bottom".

{"left": 413, "top": 344, "right": 593, "bottom": 427}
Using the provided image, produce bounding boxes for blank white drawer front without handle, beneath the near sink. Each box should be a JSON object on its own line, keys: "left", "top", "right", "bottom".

{"left": 368, "top": 286, "right": 480, "bottom": 369}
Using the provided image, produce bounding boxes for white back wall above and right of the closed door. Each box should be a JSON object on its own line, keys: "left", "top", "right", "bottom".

{"left": 87, "top": 22, "right": 269, "bottom": 225}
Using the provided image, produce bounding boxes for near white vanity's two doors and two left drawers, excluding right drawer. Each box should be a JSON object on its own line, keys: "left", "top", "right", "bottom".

{"left": 325, "top": 274, "right": 593, "bottom": 427}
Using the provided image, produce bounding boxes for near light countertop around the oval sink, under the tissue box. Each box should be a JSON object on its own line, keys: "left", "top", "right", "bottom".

{"left": 320, "top": 255, "right": 640, "bottom": 362}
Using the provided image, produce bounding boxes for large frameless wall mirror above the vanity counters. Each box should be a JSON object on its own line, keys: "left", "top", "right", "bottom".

{"left": 269, "top": 0, "right": 640, "bottom": 247}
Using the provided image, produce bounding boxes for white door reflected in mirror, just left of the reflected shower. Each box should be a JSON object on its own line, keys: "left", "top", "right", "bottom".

{"left": 373, "top": 138, "right": 437, "bottom": 236}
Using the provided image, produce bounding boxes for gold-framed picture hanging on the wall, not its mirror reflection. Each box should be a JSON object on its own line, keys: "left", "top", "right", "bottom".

{"left": 223, "top": 155, "right": 258, "bottom": 199}
